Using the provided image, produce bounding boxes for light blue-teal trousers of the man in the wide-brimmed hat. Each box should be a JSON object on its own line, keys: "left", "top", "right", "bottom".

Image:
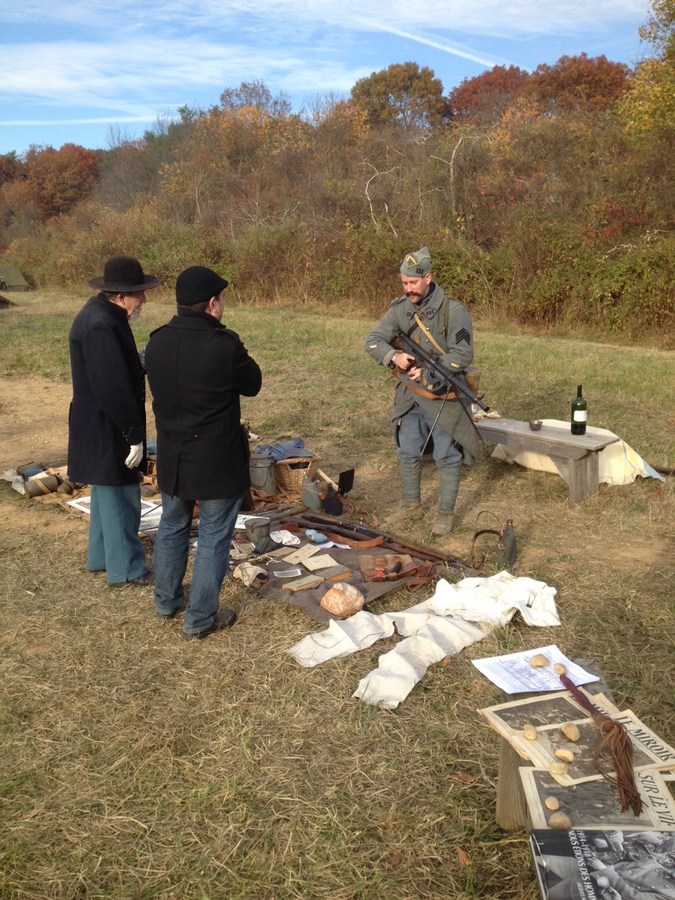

{"left": 87, "top": 484, "right": 149, "bottom": 584}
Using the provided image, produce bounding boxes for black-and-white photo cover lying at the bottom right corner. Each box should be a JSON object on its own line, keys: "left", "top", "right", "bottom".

{"left": 530, "top": 830, "right": 675, "bottom": 900}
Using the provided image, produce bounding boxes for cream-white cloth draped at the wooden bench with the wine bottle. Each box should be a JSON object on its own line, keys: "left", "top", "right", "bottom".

{"left": 492, "top": 419, "right": 665, "bottom": 485}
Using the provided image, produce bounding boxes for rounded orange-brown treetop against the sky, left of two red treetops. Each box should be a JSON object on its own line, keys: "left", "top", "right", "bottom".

{"left": 351, "top": 62, "right": 450, "bottom": 131}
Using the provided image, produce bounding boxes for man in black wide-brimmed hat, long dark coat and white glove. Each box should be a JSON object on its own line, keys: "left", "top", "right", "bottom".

{"left": 68, "top": 256, "right": 159, "bottom": 587}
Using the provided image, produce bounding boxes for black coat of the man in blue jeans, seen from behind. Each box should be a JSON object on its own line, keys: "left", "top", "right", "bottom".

{"left": 145, "top": 309, "right": 262, "bottom": 500}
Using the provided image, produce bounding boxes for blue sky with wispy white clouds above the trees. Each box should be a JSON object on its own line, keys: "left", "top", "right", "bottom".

{"left": 0, "top": 0, "right": 650, "bottom": 153}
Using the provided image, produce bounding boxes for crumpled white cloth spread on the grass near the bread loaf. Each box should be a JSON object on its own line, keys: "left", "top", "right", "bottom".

{"left": 287, "top": 572, "right": 560, "bottom": 709}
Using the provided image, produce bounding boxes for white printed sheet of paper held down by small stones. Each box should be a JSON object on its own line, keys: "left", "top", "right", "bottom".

{"left": 472, "top": 644, "right": 598, "bottom": 694}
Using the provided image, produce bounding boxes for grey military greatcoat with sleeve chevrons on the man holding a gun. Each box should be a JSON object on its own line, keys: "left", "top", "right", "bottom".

{"left": 365, "top": 282, "right": 483, "bottom": 465}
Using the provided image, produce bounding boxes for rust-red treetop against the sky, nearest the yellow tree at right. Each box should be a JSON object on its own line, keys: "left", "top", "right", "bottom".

{"left": 525, "top": 53, "right": 630, "bottom": 112}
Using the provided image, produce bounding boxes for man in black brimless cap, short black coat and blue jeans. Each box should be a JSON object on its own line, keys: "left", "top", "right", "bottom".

{"left": 145, "top": 266, "right": 262, "bottom": 640}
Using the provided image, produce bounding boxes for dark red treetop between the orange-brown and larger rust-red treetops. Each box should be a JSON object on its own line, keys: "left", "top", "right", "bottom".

{"left": 448, "top": 66, "right": 530, "bottom": 125}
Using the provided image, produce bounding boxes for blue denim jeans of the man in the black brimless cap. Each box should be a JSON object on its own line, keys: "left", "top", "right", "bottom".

{"left": 154, "top": 494, "right": 244, "bottom": 634}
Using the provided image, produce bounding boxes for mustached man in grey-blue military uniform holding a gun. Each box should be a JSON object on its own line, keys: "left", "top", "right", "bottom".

{"left": 366, "top": 247, "right": 481, "bottom": 535}
